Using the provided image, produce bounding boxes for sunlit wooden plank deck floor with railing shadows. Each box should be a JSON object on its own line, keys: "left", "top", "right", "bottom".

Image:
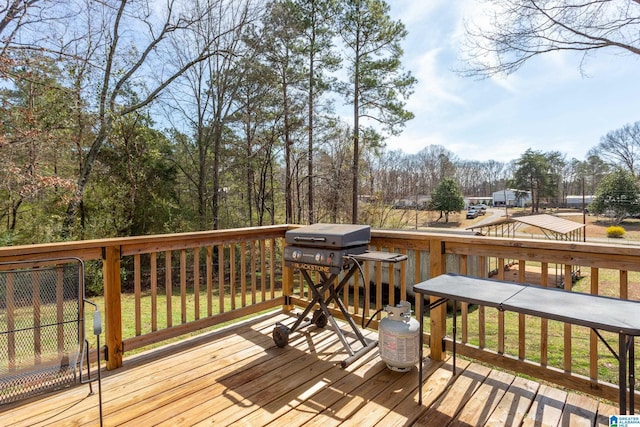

{"left": 0, "top": 314, "right": 617, "bottom": 427}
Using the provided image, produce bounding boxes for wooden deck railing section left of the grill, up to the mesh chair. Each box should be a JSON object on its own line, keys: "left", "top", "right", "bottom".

{"left": 0, "top": 226, "right": 288, "bottom": 369}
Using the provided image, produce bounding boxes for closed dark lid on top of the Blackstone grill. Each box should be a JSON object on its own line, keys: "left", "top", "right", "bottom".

{"left": 285, "top": 224, "right": 371, "bottom": 249}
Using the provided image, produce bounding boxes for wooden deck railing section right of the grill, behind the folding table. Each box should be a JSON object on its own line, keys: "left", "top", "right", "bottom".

{"left": 294, "top": 231, "right": 640, "bottom": 401}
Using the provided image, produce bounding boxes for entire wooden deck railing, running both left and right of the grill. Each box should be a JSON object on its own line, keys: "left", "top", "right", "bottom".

{"left": 0, "top": 225, "right": 640, "bottom": 408}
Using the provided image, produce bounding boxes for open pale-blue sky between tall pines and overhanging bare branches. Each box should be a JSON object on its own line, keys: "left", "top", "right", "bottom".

{"left": 387, "top": 0, "right": 640, "bottom": 162}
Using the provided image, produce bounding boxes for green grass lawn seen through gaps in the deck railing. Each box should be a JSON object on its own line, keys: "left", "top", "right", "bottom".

{"left": 6, "top": 263, "right": 640, "bottom": 392}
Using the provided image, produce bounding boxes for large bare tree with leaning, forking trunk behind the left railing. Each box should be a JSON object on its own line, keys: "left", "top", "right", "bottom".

{"left": 57, "top": 0, "right": 255, "bottom": 236}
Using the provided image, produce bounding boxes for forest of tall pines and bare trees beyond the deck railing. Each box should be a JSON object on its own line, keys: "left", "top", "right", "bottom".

{"left": 0, "top": 0, "right": 640, "bottom": 245}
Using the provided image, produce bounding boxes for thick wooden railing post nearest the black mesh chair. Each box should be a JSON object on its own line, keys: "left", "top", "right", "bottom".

{"left": 102, "top": 246, "right": 123, "bottom": 369}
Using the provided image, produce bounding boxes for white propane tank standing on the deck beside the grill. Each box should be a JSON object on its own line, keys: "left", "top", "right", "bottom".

{"left": 378, "top": 301, "right": 420, "bottom": 372}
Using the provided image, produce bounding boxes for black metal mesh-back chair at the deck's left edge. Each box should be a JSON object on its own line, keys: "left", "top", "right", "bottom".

{"left": 0, "top": 258, "right": 102, "bottom": 420}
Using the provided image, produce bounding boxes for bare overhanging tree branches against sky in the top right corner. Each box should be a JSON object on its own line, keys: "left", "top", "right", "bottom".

{"left": 463, "top": 0, "right": 640, "bottom": 77}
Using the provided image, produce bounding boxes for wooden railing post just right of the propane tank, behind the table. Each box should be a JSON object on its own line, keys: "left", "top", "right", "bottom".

{"left": 429, "top": 239, "right": 447, "bottom": 361}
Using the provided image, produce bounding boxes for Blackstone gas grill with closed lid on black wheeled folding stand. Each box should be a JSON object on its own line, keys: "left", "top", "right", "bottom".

{"left": 273, "top": 224, "right": 407, "bottom": 368}
